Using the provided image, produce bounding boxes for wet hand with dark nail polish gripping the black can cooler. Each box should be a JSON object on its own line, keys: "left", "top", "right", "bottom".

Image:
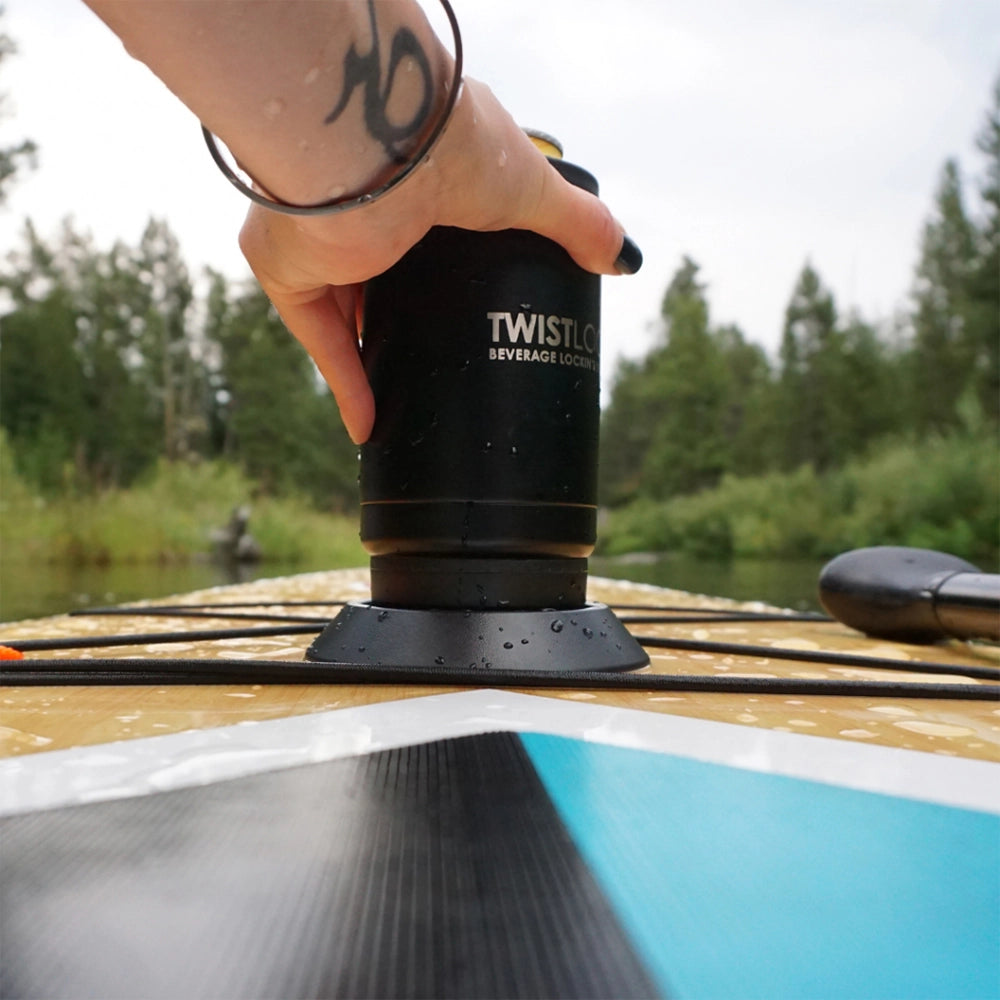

{"left": 240, "top": 80, "right": 642, "bottom": 444}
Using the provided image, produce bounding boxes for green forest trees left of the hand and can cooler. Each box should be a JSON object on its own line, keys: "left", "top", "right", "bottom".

{"left": 0, "top": 219, "right": 357, "bottom": 509}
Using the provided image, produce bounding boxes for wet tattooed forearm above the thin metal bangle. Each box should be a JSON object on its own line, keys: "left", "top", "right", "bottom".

{"left": 86, "top": 0, "right": 450, "bottom": 204}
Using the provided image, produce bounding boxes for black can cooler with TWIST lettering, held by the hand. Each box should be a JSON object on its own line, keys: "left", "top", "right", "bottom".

{"left": 361, "top": 160, "right": 600, "bottom": 603}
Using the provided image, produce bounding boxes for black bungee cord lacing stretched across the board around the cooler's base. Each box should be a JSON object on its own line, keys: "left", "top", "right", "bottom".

{"left": 0, "top": 601, "right": 1000, "bottom": 701}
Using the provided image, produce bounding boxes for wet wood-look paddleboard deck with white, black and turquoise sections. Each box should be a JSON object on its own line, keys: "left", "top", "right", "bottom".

{"left": 0, "top": 571, "right": 1000, "bottom": 998}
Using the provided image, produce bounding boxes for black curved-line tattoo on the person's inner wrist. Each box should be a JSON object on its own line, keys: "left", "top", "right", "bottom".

{"left": 324, "top": 0, "right": 434, "bottom": 163}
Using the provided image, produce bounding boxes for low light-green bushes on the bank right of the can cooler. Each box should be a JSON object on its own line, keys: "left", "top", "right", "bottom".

{"left": 599, "top": 433, "right": 1000, "bottom": 570}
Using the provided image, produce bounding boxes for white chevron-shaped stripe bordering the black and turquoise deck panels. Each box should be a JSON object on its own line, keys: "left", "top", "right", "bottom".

{"left": 0, "top": 690, "right": 1000, "bottom": 815}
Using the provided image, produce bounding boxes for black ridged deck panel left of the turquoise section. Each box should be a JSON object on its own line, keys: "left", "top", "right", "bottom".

{"left": 0, "top": 733, "right": 657, "bottom": 998}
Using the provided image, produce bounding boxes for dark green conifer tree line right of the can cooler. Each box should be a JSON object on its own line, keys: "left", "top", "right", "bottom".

{"left": 601, "top": 81, "right": 1000, "bottom": 506}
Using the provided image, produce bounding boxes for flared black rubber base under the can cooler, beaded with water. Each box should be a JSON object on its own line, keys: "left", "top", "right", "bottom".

{"left": 306, "top": 601, "right": 649, "bottom": 683}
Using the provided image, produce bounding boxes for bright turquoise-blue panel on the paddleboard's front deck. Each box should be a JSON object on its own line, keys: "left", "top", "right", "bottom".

{"left": 523, "top": 734, "right": 1000, "bottom": 1000}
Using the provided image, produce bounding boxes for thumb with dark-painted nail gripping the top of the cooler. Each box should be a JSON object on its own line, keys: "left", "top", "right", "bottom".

{"left": 522, "top": 161, "right": 642, "bottom": 274}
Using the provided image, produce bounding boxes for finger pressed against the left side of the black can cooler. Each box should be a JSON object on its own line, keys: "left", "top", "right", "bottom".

{"left": 272, "top": 288, "right": 375, "bottom": 444}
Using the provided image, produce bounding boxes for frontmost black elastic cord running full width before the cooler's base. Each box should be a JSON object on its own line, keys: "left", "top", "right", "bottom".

{"left": 0, "top": 659, "right": 1000, "bottom": 701}
